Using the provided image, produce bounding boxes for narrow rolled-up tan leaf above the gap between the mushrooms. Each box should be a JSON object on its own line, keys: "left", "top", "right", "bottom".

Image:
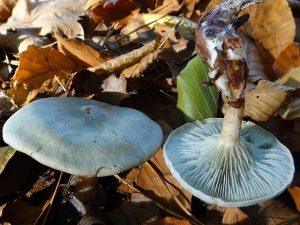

{"left": 89, "top": 39, "right": 161, "bottom": 75}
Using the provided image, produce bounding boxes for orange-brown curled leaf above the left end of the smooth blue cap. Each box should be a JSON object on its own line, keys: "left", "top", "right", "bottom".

{"left": 8, "top": 45, "right": 76, "bottom": 105}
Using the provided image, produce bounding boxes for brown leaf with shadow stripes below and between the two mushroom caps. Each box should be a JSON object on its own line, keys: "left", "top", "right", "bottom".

{"left": 121, "top": 150, "right": 192, "bottom": 218}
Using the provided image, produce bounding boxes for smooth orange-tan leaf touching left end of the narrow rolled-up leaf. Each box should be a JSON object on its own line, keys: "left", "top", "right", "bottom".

{"left": 55, "top": 35, "right": 110, "bottom": 68}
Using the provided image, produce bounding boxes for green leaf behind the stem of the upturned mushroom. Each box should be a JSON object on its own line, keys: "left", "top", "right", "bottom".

{"left": 177, "top": 56, "right": 218, "bottom": 122}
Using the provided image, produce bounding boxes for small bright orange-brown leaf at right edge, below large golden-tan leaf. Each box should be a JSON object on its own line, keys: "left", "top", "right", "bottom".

{"left": 273, "top": 43, "right": 300, "bottom": 77}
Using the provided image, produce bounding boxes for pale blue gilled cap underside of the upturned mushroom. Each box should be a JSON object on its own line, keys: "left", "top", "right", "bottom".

{"left": 164, "top": 118, "right": 295, "bottom": 207}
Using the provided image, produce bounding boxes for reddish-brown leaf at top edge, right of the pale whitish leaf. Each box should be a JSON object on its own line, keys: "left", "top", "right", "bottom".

{"left": 86, "top": 0, "right": 141, "bottom": 24}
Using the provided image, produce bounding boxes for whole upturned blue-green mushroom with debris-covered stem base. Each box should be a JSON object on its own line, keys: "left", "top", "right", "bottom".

{"left": 164, "top": 0, "right": 295, "bottom": 207}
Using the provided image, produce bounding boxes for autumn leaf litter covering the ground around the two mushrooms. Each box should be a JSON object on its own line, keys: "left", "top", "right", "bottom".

{"left": 0, "top": 0, "right": 300, "bottom": 225}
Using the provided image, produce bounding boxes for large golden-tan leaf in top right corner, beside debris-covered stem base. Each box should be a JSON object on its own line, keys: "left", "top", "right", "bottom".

{"left": 244, "top": 0, "right": 296, "bottom": 59}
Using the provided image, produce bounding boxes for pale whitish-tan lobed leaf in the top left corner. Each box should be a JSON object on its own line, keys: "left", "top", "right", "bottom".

{"left": 0, "top": 0, "right": 86, "bottom": 38}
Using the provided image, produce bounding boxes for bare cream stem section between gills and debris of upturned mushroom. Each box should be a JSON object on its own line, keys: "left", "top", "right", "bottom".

{"left": 221, "top": 104, "right": 245, "bottom": 145}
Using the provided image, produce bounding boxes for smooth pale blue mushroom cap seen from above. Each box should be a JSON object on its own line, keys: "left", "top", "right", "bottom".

{"left": 3, "top": 97, "right": 163, "bottom": 177}
